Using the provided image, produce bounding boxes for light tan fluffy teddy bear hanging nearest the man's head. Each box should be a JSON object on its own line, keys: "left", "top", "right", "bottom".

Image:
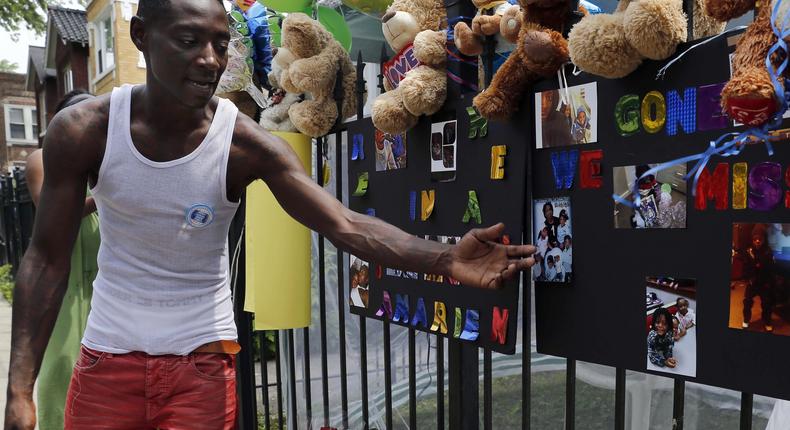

{"left": 278, "top": 13, "right": 357, "bottom": 137}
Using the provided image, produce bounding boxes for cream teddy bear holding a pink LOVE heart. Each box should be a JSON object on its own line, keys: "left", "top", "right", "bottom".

{"left": 372, "top": 0, "right": 447, "bottom": 134}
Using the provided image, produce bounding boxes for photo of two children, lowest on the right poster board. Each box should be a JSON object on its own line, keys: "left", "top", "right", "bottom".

{"left": 645, "top": 276, "right": 697, "bottom": 377}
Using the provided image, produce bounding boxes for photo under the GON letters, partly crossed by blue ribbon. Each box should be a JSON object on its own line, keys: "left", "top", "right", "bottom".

{"left": 612, "top": 164, "right": 686, "bottom": 229}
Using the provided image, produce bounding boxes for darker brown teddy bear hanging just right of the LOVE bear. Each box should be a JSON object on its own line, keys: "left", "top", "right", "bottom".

{"left": 473, "top": 0, "right": 571, "bottom": 120}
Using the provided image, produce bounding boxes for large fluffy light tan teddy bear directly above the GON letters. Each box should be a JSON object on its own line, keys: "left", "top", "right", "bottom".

{"left": 568, "top": 0, "right": 726, "bottom": 79}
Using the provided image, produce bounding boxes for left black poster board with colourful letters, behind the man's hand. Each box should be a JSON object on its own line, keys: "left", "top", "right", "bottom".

{"left": 344, "top": 106, "right": 528, "bottom": 353}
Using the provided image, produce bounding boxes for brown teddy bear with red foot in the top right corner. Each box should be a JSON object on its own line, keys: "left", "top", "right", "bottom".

{"left": 706, "top": 0, "right": 788, "bottom": 126}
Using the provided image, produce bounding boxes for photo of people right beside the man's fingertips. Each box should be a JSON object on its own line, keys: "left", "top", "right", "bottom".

{"left": 532, "top": 197, "right": 573, "bottom": 284}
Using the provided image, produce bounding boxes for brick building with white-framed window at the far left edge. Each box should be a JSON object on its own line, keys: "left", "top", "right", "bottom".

{"left": 0, "top": 73, "right": 38, "bottom": 172}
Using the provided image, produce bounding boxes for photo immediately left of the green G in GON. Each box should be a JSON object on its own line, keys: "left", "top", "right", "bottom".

{"left": 535, "top": 82, "right": 598, "bottom": 149}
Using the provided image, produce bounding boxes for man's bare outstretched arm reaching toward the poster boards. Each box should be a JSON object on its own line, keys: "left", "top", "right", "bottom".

{"left": 235, "top": 116, "right": 535, "bottom": 288}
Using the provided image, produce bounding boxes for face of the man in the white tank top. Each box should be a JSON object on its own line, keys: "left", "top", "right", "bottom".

{"left": 133, "top": 0, "right": 230, "bottom": 108}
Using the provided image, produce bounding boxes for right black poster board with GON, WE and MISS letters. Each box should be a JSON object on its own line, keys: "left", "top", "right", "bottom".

{"left": 528, "top": 32, "right": 790, "bottom": 399}
